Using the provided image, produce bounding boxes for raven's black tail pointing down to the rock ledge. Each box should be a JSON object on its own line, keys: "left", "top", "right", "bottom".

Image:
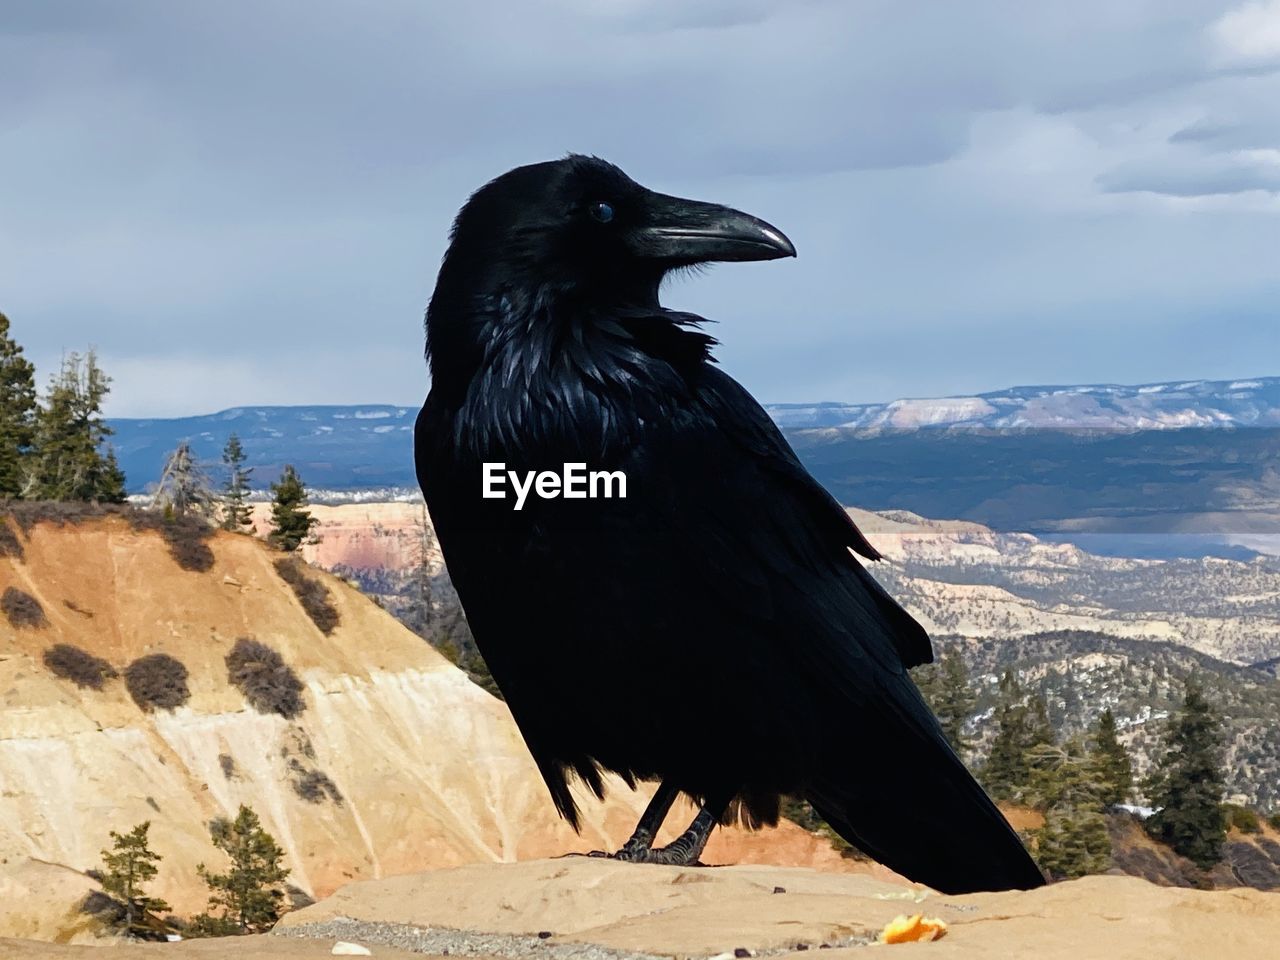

{"left": 805, "top": 732, "right": 1044, "bottom": 893}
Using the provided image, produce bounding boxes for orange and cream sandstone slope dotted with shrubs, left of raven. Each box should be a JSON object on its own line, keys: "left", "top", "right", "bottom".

{"left": 0, "top": 518, "right": 870, "bottom": 936}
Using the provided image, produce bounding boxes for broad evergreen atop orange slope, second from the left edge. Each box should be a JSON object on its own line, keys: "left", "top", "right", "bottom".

{"left": 23, "top": 351, "right": 124, "bottom": 503}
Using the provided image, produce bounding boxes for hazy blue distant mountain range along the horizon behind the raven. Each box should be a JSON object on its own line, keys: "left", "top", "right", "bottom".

{"left": 102, "top": 378, "right": 1280, "bottom": 556}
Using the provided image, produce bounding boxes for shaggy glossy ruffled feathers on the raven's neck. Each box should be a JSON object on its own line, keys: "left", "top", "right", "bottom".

{"left": 429, "top": 293, "right": 716, "bottom": 457}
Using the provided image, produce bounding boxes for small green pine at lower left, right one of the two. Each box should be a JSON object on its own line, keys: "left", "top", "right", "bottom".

{"left": 196, "top": 804, "right": 289, "bottom": 933}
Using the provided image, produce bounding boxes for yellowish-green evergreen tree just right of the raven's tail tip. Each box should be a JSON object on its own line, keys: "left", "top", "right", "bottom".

{"left": 1027, "top": 741, "right": 1111, "bottom": 879}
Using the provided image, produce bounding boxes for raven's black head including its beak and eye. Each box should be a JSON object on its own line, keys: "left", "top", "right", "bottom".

{"left": 436, "top": 156, "right": 795, "bottom": 308}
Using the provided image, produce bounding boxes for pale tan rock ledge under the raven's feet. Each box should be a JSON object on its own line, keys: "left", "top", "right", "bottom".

{"left": 0, "top": 858, "right": 1280, "bottom": 960}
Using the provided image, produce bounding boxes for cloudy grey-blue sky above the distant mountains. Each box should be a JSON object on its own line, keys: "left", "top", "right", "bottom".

{"left": 0, "top": 0, "right": 1280, "bottom": 416}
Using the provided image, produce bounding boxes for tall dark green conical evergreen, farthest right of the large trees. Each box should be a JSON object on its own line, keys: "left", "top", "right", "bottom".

{"left": 1146, "top": 678, "right": 1226, "bottom": 869}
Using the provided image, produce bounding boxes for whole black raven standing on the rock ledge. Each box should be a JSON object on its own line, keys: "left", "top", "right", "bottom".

{"left": 415, "top": 156, "right": 1043, "bottom": 893}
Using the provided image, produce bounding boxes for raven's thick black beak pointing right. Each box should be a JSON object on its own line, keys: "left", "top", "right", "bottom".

{"left": 628, "top": 193, "right": 796, "bottom": 264}
